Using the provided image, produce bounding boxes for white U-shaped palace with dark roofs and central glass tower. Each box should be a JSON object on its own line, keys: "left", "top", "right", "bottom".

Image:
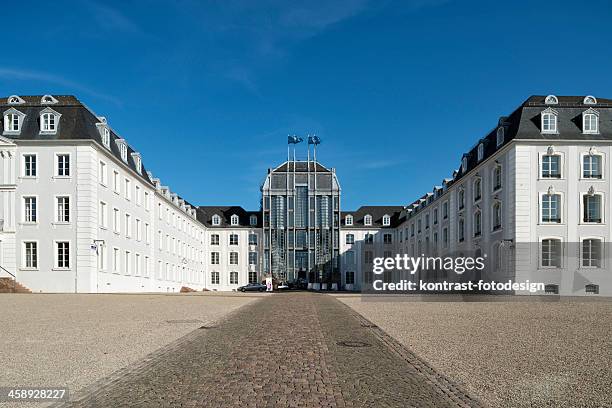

{"left": 0, "top": 95, "right": 612, "bottom": 296}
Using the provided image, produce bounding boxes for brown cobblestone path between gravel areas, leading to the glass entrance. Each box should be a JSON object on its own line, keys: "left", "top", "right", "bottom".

{"left": 55, "top": 292, "right": 480, "bottom": 408}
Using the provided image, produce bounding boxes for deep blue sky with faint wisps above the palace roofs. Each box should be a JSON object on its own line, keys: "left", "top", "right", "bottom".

{"left": 0, "top": 0, "right": 612, "bottom": 210}
